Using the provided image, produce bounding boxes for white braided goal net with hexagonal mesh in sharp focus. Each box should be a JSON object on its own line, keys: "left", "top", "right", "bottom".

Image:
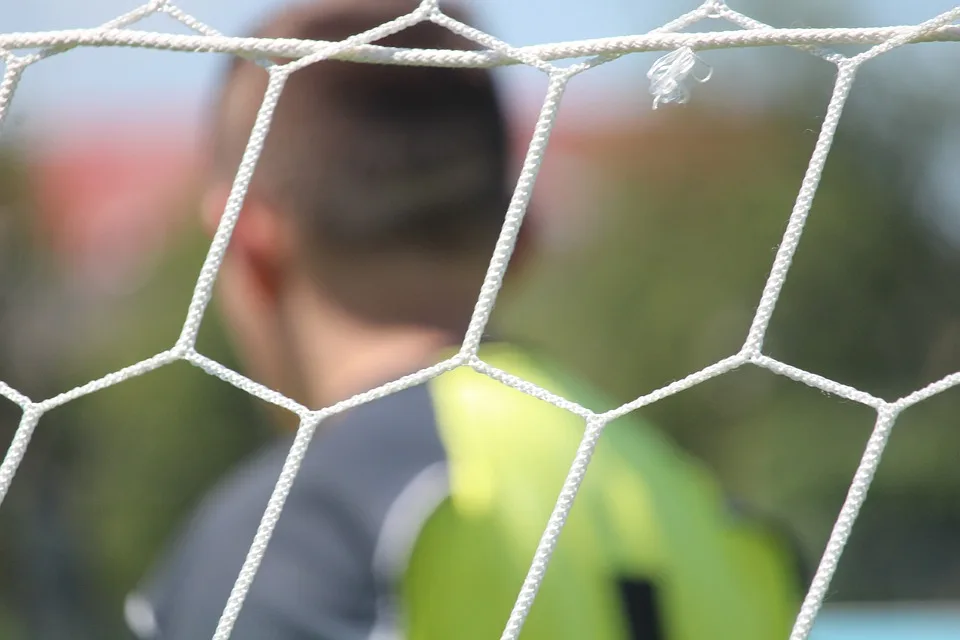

{"left": 0, "top": 0, "right": 960, "bottom": 640}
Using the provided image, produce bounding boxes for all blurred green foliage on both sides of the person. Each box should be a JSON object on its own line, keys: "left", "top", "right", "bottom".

{"left": 0, "top": 97, "right": 960, "bottom": 639}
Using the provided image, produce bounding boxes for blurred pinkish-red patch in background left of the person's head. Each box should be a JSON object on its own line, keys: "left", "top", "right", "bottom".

{"left": 29, "top": 121, "right": 199, "bottom": 294}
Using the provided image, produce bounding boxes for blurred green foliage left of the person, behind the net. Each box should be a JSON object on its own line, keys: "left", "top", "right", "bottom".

{"left": 0, "top": 162, "right": 266, "bottom": 640}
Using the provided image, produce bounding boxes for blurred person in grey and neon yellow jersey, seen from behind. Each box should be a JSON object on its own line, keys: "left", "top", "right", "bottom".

{"left": 127, "top": 0, "right": 800, "bottom": 640}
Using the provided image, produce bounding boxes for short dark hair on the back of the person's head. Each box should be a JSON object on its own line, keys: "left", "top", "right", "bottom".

{"left": 212, "top": 0, "right": 509, "bottom": 258}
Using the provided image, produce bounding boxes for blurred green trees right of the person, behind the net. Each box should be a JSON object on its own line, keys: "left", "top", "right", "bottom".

{"left": 504, "top": 99, "right": 960, "bottom": 599}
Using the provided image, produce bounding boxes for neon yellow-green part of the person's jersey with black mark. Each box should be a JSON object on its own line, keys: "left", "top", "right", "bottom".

{"left": 403, "top": 344, "right": 801, "bottom": 640}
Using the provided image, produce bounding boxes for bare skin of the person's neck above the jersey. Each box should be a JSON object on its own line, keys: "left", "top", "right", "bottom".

{"left": 291, "top": 288, "right": 462, "bottom": 409}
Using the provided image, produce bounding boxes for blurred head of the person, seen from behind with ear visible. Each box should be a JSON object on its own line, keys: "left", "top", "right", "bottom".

{"left": 203, "top": 0, "right": 524, "bottom": 408}
